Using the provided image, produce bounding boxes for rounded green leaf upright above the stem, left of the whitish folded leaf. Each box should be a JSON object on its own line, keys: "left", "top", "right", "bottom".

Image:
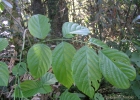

{"left": 28, "top": 14, "right": 50, "bottom": 39}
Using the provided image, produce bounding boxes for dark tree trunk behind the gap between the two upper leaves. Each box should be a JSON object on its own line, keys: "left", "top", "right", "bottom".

{"left": 47, "top": 0, "right": 68, "bottom": 37}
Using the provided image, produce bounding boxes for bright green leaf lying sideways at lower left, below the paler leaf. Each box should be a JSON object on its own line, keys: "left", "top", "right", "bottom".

{"left": 20, "top": 80, "right": 52, "bottom": 97}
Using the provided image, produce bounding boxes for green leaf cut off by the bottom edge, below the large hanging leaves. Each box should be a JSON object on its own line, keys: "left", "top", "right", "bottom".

{"left": 60, "top": 90, "right": 80, "bottom": 100}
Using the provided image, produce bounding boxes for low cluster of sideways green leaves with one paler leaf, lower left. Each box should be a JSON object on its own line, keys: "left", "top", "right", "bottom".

{"left": 13, "top": 72, "right": 57, "bottom": 98}
